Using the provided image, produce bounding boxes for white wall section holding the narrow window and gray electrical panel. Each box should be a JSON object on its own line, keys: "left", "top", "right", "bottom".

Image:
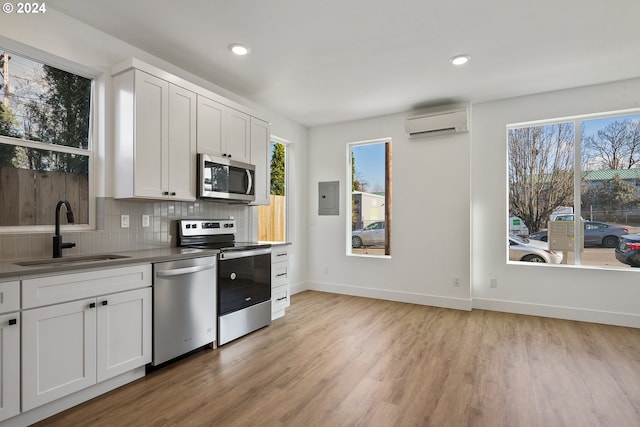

{"left": 307, "top": 110, "right": 471, "bottom": 309}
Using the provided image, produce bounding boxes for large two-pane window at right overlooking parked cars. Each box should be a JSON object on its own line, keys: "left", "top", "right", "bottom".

{"left": 507, "top": 111, "right": 640, "bottom": 268}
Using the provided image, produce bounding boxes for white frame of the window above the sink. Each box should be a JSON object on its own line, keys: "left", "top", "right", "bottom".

{"left": 0, "top": 43, "right": 97, "bottom": 235}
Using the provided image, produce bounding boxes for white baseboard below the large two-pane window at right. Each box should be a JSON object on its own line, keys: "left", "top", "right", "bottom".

{"left": 473, "top": 298, "right": 640, "bottom": 328}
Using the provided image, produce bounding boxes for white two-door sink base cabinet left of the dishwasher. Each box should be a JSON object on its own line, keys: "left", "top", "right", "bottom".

{"left": 22, "top": 264, "right": 151, "bottom": 411}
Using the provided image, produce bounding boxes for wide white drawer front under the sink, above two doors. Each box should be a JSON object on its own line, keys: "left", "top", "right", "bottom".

{"left": 22, "top": 264, "right": 151, "bottom": 309}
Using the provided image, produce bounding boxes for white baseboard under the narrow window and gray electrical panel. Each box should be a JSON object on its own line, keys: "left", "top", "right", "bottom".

{"left": 298, "top": 282, "right": 472, "bottom": 311}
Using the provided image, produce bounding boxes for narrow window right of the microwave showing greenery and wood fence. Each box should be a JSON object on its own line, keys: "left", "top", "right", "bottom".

{"left": 258, "top": 141, "right": 287, "bottom": 242}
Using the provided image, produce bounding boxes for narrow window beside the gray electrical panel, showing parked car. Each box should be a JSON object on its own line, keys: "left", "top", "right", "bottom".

{"left": 347, "top": 140, "right": 391, "bottom": 256}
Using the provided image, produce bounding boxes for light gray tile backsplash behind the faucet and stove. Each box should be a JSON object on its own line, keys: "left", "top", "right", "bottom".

{"left": 0, "top": 197, "right": 250, "bottom": 261}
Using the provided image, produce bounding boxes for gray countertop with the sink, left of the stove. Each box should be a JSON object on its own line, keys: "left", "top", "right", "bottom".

{"left": 0, "top": 248, "right": 220, "bottom": 281}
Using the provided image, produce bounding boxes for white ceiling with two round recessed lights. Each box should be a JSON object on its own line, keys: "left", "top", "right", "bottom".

{"left": 47, "top": 0, "right": 640, "bottom": 126}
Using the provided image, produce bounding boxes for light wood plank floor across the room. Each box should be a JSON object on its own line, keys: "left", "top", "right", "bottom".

{"left": 33, "top": 291, "right": 640, "bottom": 427}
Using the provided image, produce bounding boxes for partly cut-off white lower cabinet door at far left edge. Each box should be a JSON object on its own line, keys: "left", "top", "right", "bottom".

{"left": 0, "top": 310, "right": 20, "bottom": 421}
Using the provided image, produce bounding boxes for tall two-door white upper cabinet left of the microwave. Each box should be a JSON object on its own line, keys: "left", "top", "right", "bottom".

{"left": 113, "top": 69, "right": 196, "bottom": 201}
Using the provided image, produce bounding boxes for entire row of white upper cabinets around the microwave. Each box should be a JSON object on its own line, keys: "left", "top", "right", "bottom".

{"left": 112, "top": 58, "right": 270, "bottom": 205}
